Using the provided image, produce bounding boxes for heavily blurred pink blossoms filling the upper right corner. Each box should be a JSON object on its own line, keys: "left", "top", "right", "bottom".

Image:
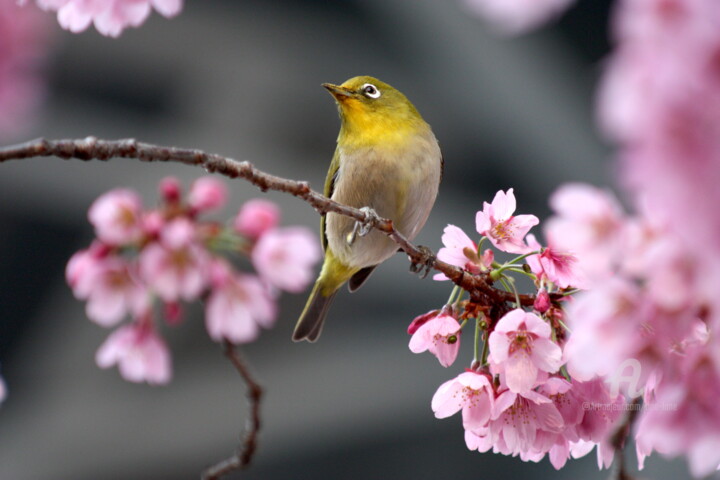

{"left": 598, "top": 0, "right": 720, "bottom": 256}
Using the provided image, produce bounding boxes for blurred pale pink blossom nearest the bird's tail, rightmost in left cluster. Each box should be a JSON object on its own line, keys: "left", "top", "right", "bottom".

{"left": 252, "top": 227, "right": 321, "bottom": 292}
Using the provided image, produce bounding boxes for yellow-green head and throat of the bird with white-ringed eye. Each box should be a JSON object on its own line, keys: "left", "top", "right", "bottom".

{"left": 323, "top": 76, "right": 427, "bottom": 145}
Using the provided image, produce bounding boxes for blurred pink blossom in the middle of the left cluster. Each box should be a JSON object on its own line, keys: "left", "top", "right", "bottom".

{"left": 139, "top": 218, "right": 210, "bottom": 302}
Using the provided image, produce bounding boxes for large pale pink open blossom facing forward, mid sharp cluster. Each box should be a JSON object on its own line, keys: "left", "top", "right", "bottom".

{"left": 488, "top": 309, "right": 562, "bottom": 393}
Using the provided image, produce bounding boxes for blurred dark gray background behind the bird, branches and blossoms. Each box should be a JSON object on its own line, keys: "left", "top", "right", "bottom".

{"left": 0, "top": 0, "right": 687, "bottom": 480}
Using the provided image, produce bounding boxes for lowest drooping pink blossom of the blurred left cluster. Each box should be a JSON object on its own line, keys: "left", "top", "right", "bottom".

{"left": 95, "top": 322, "right": 172, "bottom": 385}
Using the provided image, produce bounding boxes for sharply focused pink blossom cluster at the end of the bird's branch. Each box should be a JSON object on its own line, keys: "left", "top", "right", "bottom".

{"left": 408, "top": 189, "right": 626, "bottom": 468}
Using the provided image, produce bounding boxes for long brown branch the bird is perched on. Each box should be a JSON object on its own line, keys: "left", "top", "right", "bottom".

{"left": 0, "top": 137, "right": 559, "bottom": 306}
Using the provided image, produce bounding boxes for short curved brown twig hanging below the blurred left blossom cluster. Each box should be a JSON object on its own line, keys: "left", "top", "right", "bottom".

{"left": 202, "top": 340, "right": 263, "bottom": 480}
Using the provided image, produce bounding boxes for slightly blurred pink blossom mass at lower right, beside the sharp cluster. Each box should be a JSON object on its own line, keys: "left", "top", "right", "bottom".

{"left": 546, "top": 185, "right": 720, "bottom": 476}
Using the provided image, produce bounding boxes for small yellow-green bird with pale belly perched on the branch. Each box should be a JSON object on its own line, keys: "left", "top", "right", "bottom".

{"left": 292, "top": 76, "right": 443, "bottom": 342}
